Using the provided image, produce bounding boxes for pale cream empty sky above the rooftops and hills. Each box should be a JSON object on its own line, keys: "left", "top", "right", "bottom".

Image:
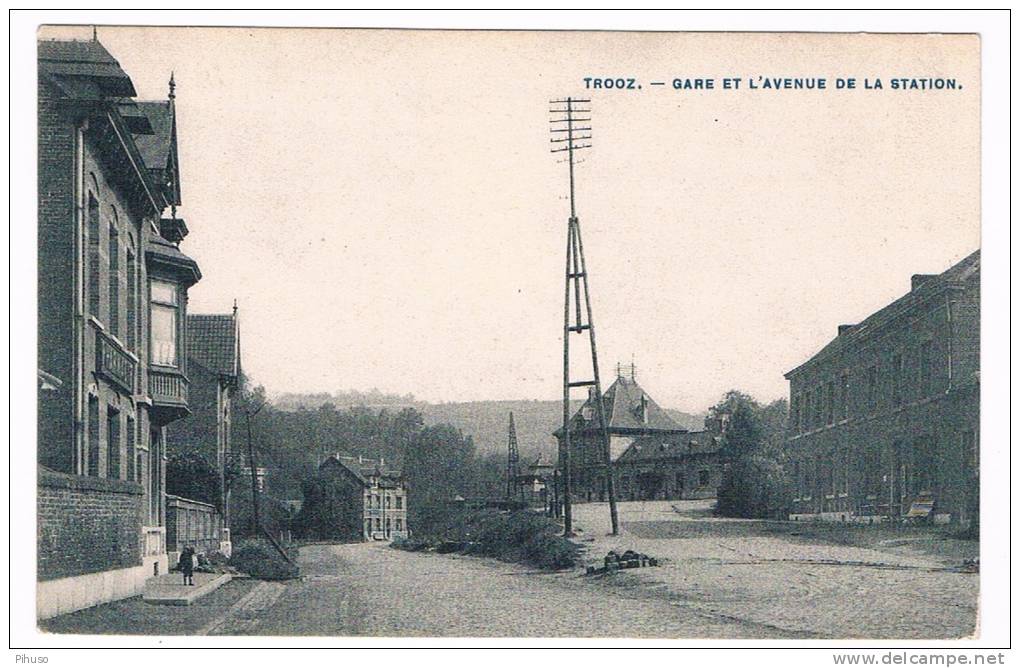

{"left": 41, "top": 27, "right": 980, "bottom": 412}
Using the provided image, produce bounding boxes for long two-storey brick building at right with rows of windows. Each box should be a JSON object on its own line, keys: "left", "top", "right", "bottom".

{"left": 785, "top": 251, "right": 980, "bottom": 525}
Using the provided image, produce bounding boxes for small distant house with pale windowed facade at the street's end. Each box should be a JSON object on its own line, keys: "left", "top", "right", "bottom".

{"left": 316, "top": 454, "right": 409, "bottom": 541}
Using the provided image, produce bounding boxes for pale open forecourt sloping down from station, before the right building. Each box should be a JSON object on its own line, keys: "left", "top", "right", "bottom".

{"left": 574, "top": 501, "right": 979, "bottom": 638}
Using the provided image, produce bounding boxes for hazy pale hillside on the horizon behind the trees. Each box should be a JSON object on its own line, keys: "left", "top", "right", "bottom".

{"left": 273, "top": 392, "right": 705, "bottom": 459}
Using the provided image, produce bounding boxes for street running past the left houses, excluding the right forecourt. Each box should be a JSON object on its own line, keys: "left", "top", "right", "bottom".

{"left": 219, "top": 544, "right": 789, "bottom": 637}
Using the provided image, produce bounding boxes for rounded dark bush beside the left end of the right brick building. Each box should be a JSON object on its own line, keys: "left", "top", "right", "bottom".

{"left": 715, "top": 455, "right": 791, "bottom": 519}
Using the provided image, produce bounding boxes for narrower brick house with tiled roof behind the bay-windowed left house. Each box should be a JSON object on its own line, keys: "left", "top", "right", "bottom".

{"left": 167, "top": 305, "right": 243, "bottom": 561}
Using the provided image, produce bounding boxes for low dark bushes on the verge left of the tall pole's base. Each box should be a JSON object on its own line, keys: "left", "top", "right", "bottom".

{"left": 392, "top": 510, "right": 580, "bottom": 570}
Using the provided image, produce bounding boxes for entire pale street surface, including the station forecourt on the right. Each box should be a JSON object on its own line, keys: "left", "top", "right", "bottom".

{"left": 209, "top": 502, "right": 978, "bottom": 637}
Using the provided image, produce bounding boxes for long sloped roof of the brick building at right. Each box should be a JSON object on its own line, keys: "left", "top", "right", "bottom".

{"left": 783, "top": 249, "right": 981, "bottom": 379}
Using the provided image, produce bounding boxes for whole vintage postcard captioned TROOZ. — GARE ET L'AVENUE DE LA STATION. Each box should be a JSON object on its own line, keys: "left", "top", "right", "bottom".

{"left": 11, "top": 13, "right": 1003, "bottom": 663}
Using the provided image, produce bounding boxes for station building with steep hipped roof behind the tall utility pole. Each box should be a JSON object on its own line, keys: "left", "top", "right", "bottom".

{"left": 554, "top": 369, "right": 721, "bottom": 501}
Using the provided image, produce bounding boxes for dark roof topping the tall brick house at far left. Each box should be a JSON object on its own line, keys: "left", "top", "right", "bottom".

{"left": 37, "top": 40, "right": 136, "bottom": 98}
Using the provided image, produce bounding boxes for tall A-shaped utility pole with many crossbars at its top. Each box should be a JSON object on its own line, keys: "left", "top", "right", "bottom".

{"left": 549, "top": 97, "right": 619, "bottom": 535}
